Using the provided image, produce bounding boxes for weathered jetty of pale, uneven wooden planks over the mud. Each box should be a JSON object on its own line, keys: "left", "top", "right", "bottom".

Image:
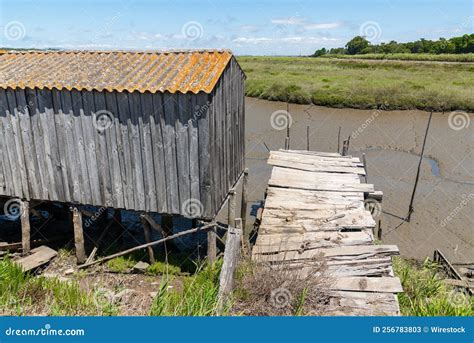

{"left": 252, "top": 150, "right": 403, "bottom": 315}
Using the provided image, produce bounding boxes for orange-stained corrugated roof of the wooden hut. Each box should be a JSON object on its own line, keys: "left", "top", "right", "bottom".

{"left": 0, "top": 50, "right": 232, "bottom": 93}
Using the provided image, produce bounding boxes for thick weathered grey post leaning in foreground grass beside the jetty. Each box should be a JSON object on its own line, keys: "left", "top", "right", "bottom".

{"left": 217, "top": 219, "right": 242, "bottom": 314}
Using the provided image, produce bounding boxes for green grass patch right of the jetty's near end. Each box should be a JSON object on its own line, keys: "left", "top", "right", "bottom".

{"left": 393, "top": 258, "right": 474, "bottom": 316}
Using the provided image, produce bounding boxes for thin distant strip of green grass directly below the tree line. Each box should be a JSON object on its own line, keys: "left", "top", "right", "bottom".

{"left": 319, "top": 53, "right": 474, "bottom": 62}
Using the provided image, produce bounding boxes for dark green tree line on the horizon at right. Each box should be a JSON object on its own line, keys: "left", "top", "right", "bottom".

{"left": 312, "top": 34, "right": 474, "bottom": 57}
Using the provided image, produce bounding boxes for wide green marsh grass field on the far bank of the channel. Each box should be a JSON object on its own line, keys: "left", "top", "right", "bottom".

{"left": 238, "top": 56, "right": 474, "bottom": 111}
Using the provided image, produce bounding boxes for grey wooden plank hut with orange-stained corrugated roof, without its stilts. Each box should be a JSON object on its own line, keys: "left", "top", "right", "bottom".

{"left": 0, "top": 50, "right": 245, "bottom": 219}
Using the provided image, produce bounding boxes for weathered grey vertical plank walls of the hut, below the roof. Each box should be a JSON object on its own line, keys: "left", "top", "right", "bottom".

{"left": 0, "top": 59, "right": 244, "bottom": 218}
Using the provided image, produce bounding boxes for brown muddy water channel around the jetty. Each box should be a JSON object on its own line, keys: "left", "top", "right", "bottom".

{"left": 246, "top": 98, "right": 474, "bottom": 263}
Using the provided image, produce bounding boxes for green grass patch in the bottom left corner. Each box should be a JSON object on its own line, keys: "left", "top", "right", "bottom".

{"left": 0, "top": 257, "right": 117, "bottom": 316}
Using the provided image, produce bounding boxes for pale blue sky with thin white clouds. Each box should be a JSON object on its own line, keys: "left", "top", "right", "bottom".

{"left": 0, "top": 0, "right": 474, "bottom": 55}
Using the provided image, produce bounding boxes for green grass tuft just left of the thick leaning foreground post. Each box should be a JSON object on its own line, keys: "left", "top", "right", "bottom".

{"left": 150, "top": 261, "right": 228, "bottom": 316}
